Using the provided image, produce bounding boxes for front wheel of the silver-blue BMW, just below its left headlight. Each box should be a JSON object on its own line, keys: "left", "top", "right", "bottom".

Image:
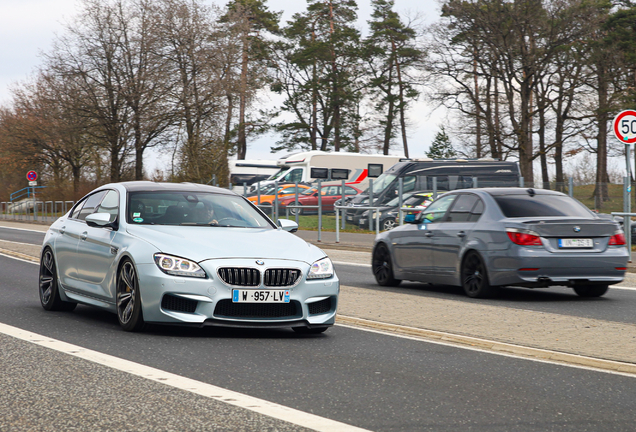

{"left": 117, "top": 259, "right": 145, "bottom": 332}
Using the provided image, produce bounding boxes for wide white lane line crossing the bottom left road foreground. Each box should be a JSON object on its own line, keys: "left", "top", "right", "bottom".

{"left": 0, "top": 323, "right": 367, "bottom": 432}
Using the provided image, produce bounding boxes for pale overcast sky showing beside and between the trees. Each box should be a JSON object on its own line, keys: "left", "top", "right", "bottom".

{"left": 0, "top": 0, "right": 441, "bottom": 169}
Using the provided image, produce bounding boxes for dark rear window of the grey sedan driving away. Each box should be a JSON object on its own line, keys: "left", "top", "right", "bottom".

{"left": 493, "top": 195, "right": 592, "bottom": 219}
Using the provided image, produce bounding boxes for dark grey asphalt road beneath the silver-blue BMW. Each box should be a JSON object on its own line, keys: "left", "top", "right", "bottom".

{"left": 0, "top": 251, "right": 636, "bottom": 432}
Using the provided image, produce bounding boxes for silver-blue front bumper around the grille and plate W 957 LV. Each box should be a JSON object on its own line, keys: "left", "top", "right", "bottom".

{"left": 137, "top": 259, "right": 340, "bottom": 328}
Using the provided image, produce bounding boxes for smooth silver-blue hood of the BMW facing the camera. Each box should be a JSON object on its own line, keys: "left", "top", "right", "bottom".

{"left": 127, "top": 225, "right": 326, "bottom": 264}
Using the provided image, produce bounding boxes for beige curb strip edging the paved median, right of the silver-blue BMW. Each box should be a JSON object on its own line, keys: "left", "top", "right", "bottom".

{"left": 336, "top": 315, "right": 636, "bottom": 376}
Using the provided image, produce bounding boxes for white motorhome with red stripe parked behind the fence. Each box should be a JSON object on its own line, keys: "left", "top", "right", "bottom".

{"left": 250, "top": 150, "right": 402, "bottom": 190}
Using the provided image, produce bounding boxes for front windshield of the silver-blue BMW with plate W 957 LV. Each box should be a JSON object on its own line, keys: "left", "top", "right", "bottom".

{"left": 126, "top": 191, "right": 273, "bottom": 228}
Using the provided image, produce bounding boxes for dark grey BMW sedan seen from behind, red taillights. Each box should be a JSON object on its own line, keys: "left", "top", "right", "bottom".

{"left": 372, "top": 188, "right": 629, "bottom": 297}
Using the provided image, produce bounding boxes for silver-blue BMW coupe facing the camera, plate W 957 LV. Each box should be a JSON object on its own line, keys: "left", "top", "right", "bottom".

{"left": 39, "top": 182, "right": 339, "bottom": 333}
